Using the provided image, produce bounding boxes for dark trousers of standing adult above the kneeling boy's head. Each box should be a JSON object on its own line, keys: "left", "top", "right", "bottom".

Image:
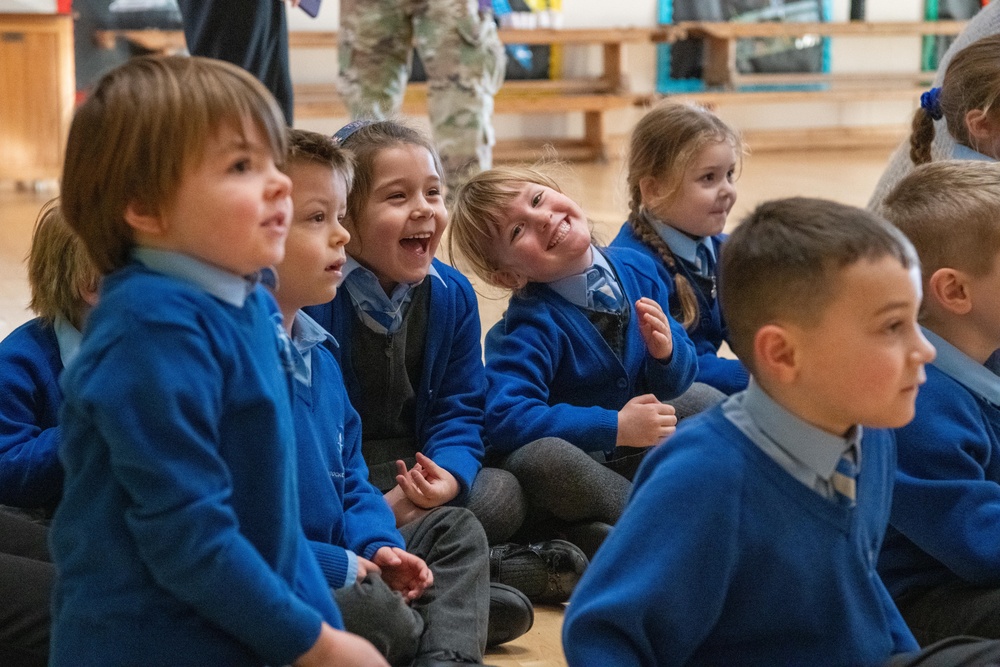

{"left": 177, "top": 0, "right": 294, "bottom": 125}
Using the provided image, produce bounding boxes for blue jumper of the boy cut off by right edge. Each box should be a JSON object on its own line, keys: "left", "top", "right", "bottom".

{"left": 879, "top": 365, "right": 1000, "bottom": 596}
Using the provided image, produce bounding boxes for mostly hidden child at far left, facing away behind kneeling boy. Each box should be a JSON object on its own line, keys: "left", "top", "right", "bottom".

{"left": 0, "top": 199, "right": 99, "bottom": 518}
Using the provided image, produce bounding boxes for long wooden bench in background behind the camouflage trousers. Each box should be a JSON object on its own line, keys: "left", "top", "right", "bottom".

{"left": 95, "top": 28, "right": 661, "bottom": 160}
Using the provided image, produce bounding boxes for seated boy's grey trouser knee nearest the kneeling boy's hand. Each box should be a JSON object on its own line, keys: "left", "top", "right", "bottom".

{"left": 333, "top": 574, "right": 424, "bottom": 665}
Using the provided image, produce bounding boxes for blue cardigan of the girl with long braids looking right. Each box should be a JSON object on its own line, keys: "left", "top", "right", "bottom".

{"left": 611, "top": 222, "right": 750, "bottom": 394}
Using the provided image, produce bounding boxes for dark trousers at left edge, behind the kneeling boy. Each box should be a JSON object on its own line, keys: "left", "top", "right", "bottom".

{"left": 0, "top": 512, "right": 55, "bottom": 665}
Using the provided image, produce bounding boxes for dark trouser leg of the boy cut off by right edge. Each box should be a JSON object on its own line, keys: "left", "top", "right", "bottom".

{"left": 896, "top": 582, "right": 1000, "bottom": 646}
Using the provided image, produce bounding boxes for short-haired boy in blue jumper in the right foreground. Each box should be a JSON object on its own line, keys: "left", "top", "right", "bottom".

{"left": 563, "top": 199, "right": 934, "bottom": 665}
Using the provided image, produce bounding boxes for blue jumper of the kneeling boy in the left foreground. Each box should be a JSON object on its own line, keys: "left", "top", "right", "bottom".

{"left": 50, "top": 263, "right": 343, "bottom": 665}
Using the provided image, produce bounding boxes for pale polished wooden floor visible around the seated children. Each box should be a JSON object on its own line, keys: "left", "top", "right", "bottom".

{"left": 0, "top": 144, "right": 889, "bottom": 667}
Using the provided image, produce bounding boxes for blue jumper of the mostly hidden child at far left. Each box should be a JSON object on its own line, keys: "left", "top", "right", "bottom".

{"left": 0, "top": 319, "right": 63, "bottom": 510}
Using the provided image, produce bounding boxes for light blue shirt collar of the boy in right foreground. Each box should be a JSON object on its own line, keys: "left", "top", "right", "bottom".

{"left": 722, "top": 379, "right": 862, "bottom": 499}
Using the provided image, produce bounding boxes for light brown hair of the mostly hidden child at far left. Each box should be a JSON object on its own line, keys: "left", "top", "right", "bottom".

{"left": 28, "top": 197, "right": 100, "bottom": 329}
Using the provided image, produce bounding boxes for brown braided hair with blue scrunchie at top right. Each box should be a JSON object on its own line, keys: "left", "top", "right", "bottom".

{"left": 910, "top": 35, "right": 1000, "bottom": 164}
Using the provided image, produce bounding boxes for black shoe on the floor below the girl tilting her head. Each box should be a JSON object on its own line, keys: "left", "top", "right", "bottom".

{"left": 490, "top": 540, "right": 590, "bottom": 604}
